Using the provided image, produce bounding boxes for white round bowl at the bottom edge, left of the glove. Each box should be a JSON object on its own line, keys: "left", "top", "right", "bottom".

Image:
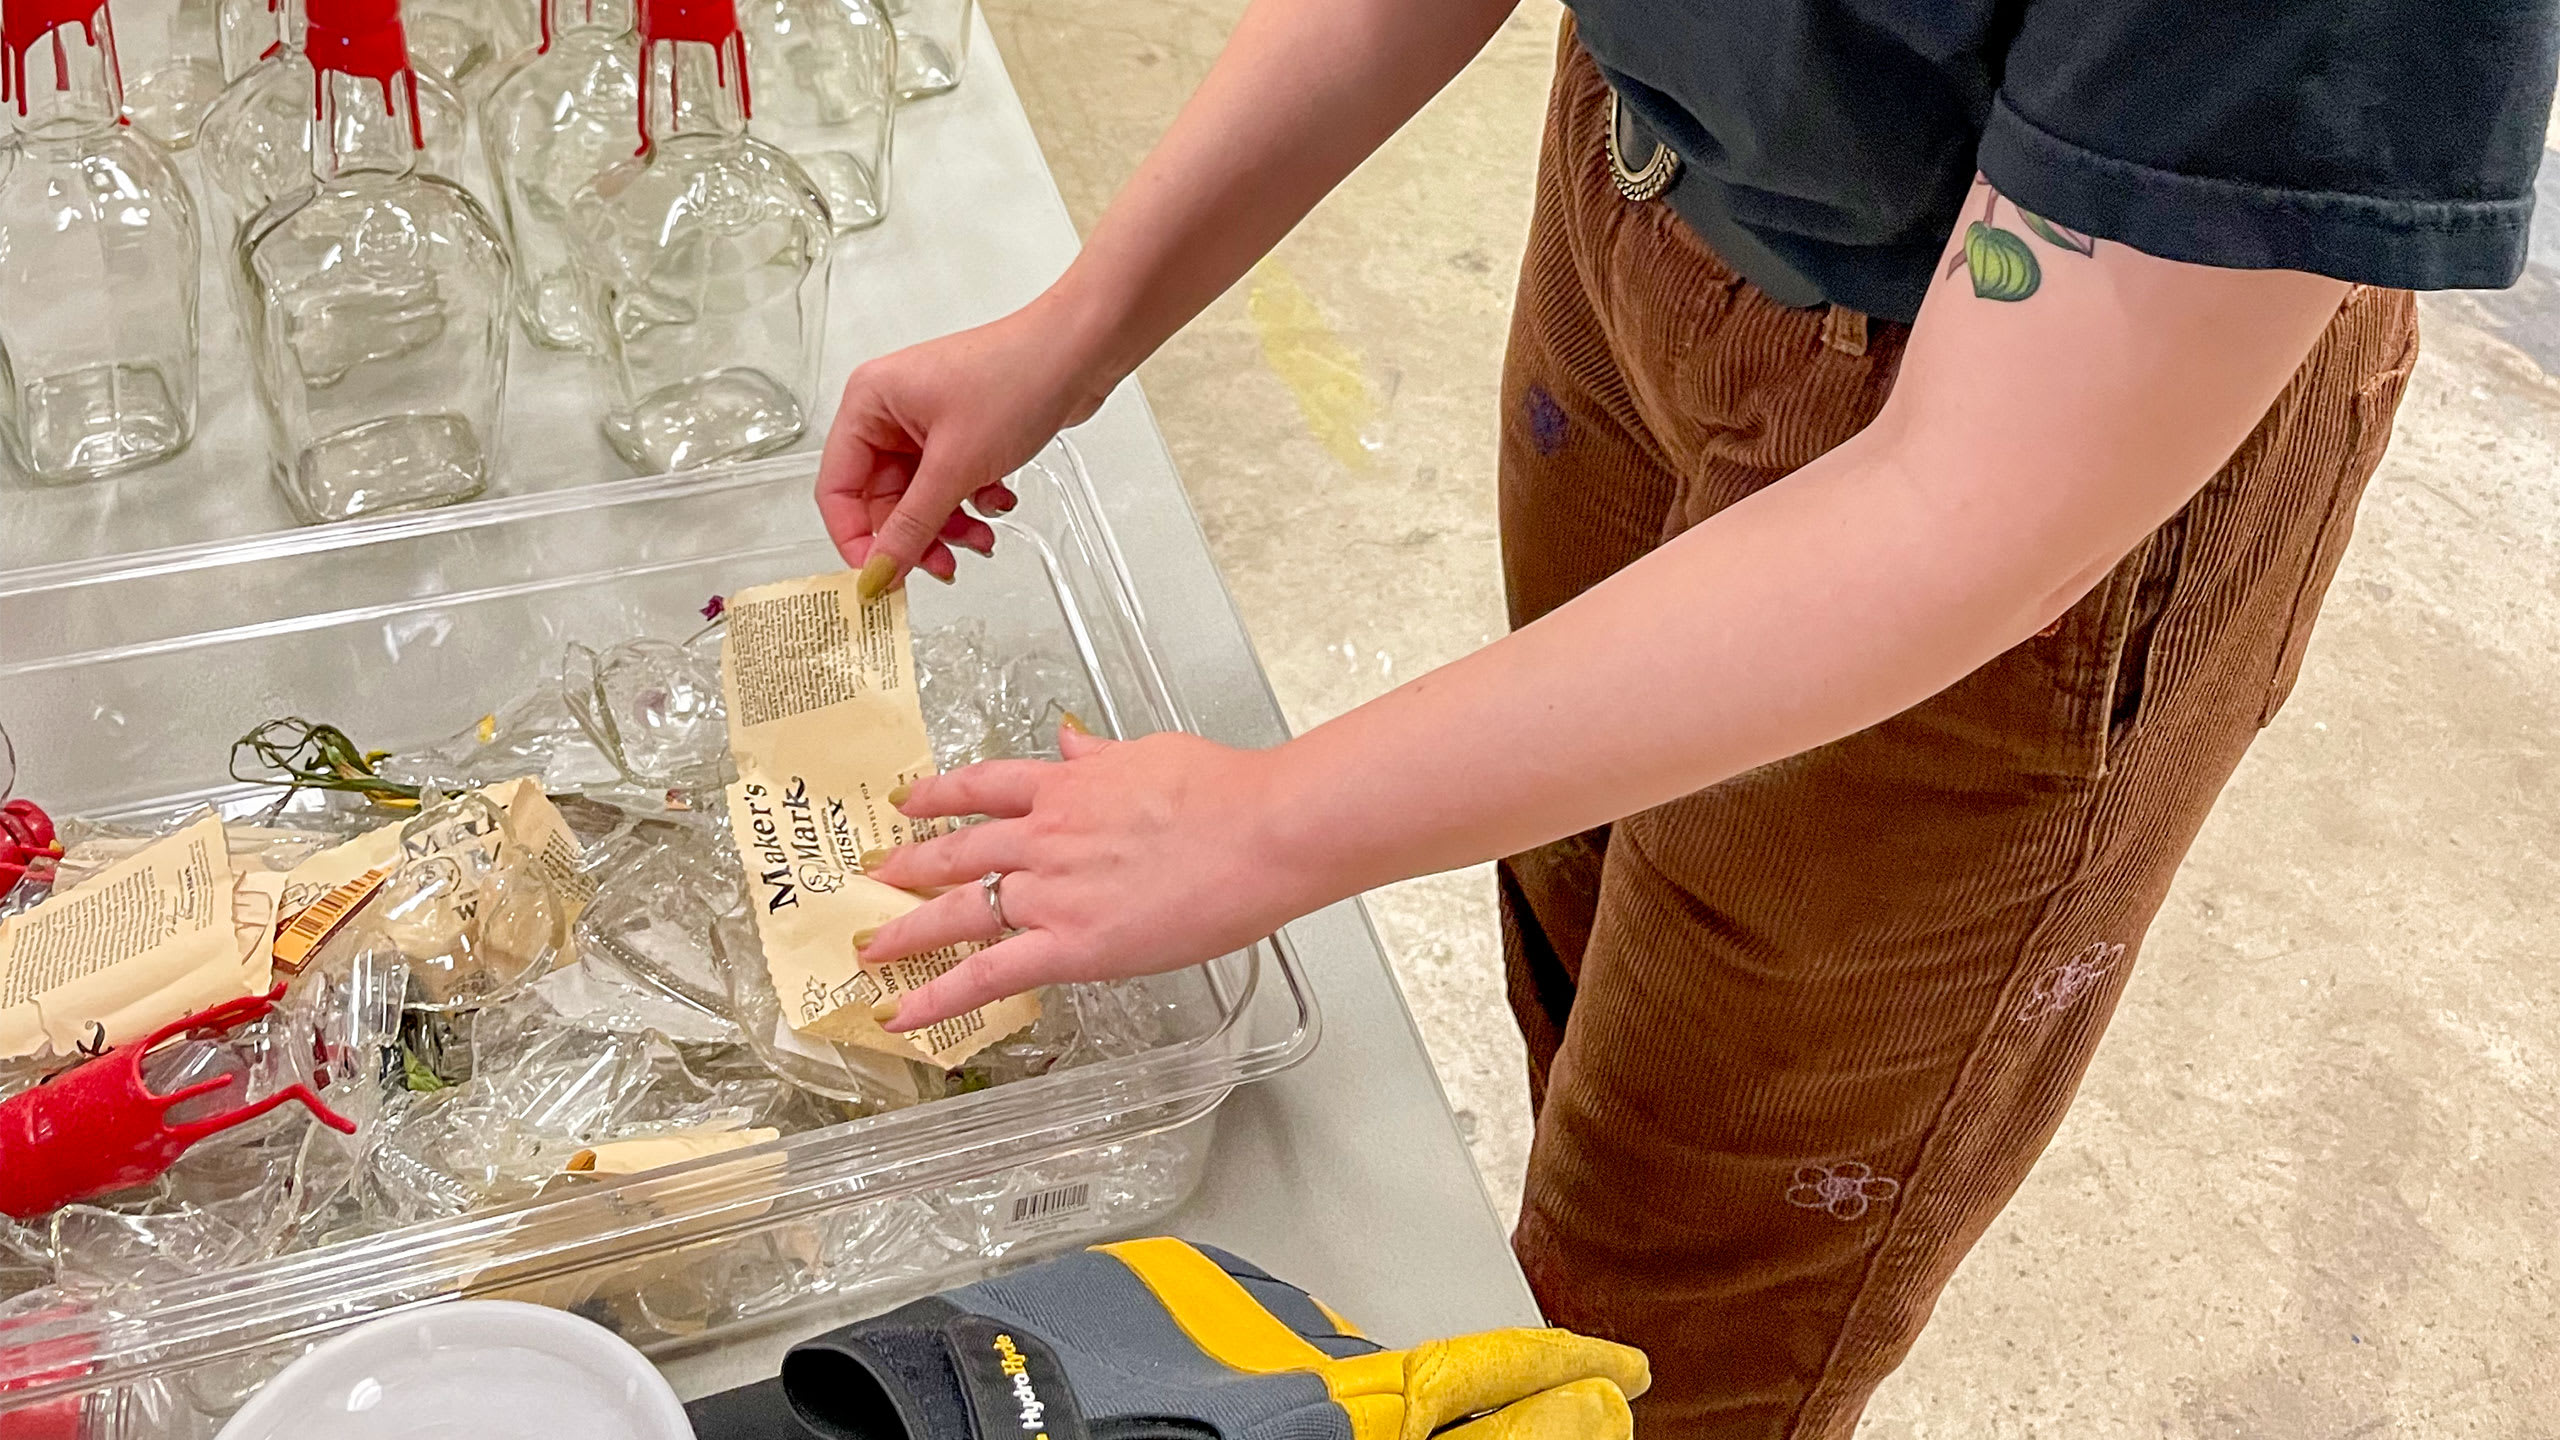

{"left": 215, "top": 1299, "right": 694, "bottom": 1440}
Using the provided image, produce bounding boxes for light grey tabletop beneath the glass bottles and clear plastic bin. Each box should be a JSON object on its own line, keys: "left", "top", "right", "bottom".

{"left": 0, "top": 0, "right": 1536, "bottom": 1394}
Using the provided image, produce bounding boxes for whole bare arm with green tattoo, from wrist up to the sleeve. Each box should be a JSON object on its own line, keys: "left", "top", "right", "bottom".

{"left": 1272, "top": 256, "right": 2342, "bottom": 904}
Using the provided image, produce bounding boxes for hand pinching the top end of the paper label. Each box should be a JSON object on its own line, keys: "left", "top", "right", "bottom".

{"left": 817, "top": 292, "right": 1119, "bottom": 594}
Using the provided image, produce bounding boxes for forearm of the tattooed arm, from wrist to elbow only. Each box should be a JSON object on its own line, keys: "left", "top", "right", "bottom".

{"left": 1272, "top": 417, "right": 2109, "bottom": 899}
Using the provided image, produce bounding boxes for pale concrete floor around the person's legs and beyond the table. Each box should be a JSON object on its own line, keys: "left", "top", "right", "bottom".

{"left": 988, "top": 0, "right": 2560, "bottom": 1440}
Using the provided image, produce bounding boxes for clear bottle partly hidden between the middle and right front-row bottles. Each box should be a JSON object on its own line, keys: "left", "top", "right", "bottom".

{"left": 481, "top": 0, "right": 640, "bottom": 351}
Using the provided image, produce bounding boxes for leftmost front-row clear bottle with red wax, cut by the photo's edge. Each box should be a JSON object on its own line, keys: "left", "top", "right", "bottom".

{"left": 0, "top": 0, "right": 197, "bottom": 482}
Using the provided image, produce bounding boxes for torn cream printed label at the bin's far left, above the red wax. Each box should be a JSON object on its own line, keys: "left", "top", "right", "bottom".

{"left": 0, "top": 812, "right": 284, "bottom": 1058}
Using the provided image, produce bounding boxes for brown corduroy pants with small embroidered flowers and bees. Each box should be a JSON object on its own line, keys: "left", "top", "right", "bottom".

{"left": 1500, "top": 33, "right": 2417, "bottom": 1440}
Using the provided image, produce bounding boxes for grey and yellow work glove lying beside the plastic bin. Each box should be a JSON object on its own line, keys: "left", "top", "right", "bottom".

{"left": 691, "top": 1240, "right": 1649, "bottom": 1440}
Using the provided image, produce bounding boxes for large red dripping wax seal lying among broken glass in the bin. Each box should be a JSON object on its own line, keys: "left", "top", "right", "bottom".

{"left": 0, "top": 984, "right": 356, "bottom": 1220}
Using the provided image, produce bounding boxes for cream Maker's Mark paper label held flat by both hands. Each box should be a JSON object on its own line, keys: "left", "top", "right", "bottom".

{"left": 719, "top": 571, "right": 1039, "bottom": 1068}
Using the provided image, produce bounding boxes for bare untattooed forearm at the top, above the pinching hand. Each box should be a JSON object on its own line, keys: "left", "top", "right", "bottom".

{"left": 1044, "top": 0, "right": 1516, "bottom": 382}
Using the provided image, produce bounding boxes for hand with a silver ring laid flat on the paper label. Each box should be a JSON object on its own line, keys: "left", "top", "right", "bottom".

{"left": 863, "top": 728, "right": 1334, "bottom": 1030}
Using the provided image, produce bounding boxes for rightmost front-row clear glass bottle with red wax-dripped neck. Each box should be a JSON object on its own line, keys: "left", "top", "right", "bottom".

{"left": 571, "top": 0, "right": 832, "bottom": 471}
